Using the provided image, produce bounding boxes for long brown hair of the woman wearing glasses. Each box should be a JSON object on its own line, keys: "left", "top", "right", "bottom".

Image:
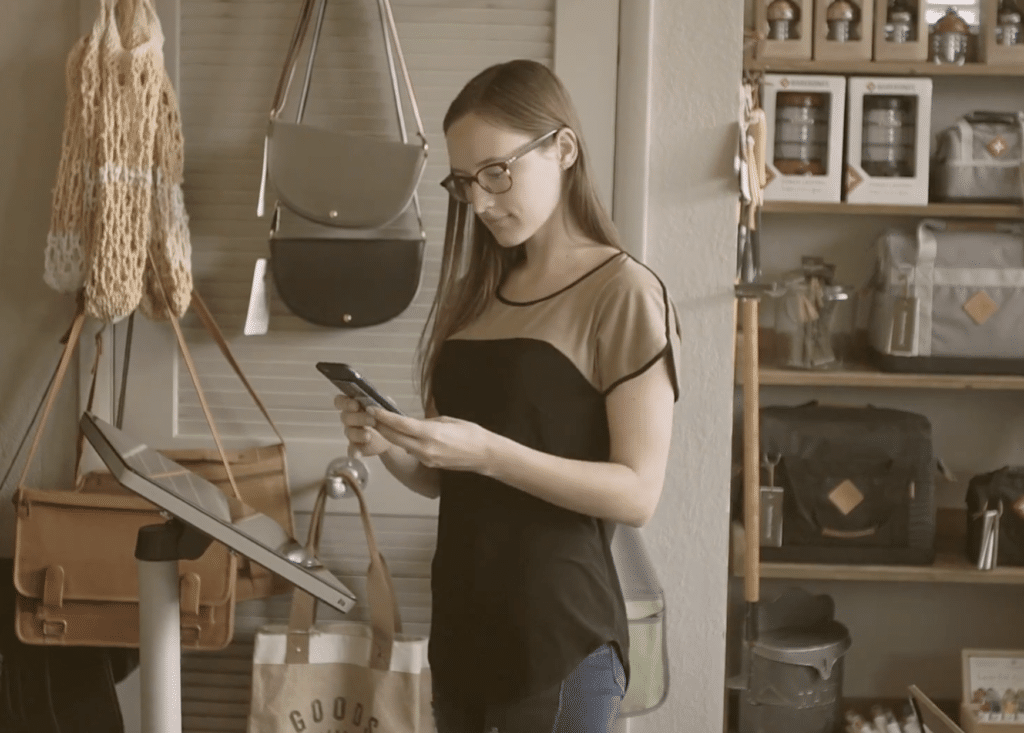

{"left": 417, "top": 59, "right": 622, "bottom": 407}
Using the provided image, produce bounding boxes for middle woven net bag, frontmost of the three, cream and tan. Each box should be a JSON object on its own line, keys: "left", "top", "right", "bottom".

{"left": 85, "top": 0, "right": 164, "bottom": 322}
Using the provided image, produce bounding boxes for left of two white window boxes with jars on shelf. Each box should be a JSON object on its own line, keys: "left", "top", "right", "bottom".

{"left": 761, "top": 74, "right": 846, "bottom": 202}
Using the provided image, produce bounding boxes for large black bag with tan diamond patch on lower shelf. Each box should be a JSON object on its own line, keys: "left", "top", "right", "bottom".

{"left": 761, "top": 403, "right": 935, "bottom": 565}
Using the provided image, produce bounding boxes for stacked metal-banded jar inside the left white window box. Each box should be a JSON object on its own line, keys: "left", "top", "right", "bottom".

{"left": 774, "top": 92, "right": 829, "bottom": 176}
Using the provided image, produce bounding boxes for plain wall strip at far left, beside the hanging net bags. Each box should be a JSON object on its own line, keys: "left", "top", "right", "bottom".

{"left": 0, "top": 0, "right": 79, "bottom": 557}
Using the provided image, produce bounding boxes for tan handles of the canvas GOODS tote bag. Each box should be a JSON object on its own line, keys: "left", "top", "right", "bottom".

{"left": 285, "top": 458, "right": 401, "bottom": 671}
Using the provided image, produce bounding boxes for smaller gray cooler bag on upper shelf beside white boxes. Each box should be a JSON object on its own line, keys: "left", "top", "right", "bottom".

{"left": 931, "top": 112, "right": 1024, "bottom": 202}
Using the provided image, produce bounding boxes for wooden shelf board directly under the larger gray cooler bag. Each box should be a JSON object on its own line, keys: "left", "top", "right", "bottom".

{"left": 753, "top": 365, "right": 1024, "bottom": 390}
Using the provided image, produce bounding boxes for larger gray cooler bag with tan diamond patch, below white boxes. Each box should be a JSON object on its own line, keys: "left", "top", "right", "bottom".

{"left": 869, "top": 219, "right": 1024, "bottom": 374}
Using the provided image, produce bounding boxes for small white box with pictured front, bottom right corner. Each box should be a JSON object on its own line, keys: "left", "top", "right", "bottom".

{"left": 961, "top": 649, "right": 1024, "bottom": 733}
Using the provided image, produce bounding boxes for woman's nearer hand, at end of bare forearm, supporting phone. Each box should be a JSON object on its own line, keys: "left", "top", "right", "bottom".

{"left": 369, "top": 407, "right": 493, "bottom": 473}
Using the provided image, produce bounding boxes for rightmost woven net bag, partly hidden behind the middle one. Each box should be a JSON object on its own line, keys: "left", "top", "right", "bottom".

{"left": 140, "top": 67, "right": 193, "bottom": 320}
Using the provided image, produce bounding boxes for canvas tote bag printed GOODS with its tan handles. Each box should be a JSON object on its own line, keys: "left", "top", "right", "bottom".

{"left": 249, "top": 472, "right": 434, "bottom": 733}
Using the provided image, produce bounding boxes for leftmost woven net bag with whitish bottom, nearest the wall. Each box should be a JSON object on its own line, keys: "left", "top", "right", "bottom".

{"left": 43, "top": 9, "right": 106, "bottom": 293}
